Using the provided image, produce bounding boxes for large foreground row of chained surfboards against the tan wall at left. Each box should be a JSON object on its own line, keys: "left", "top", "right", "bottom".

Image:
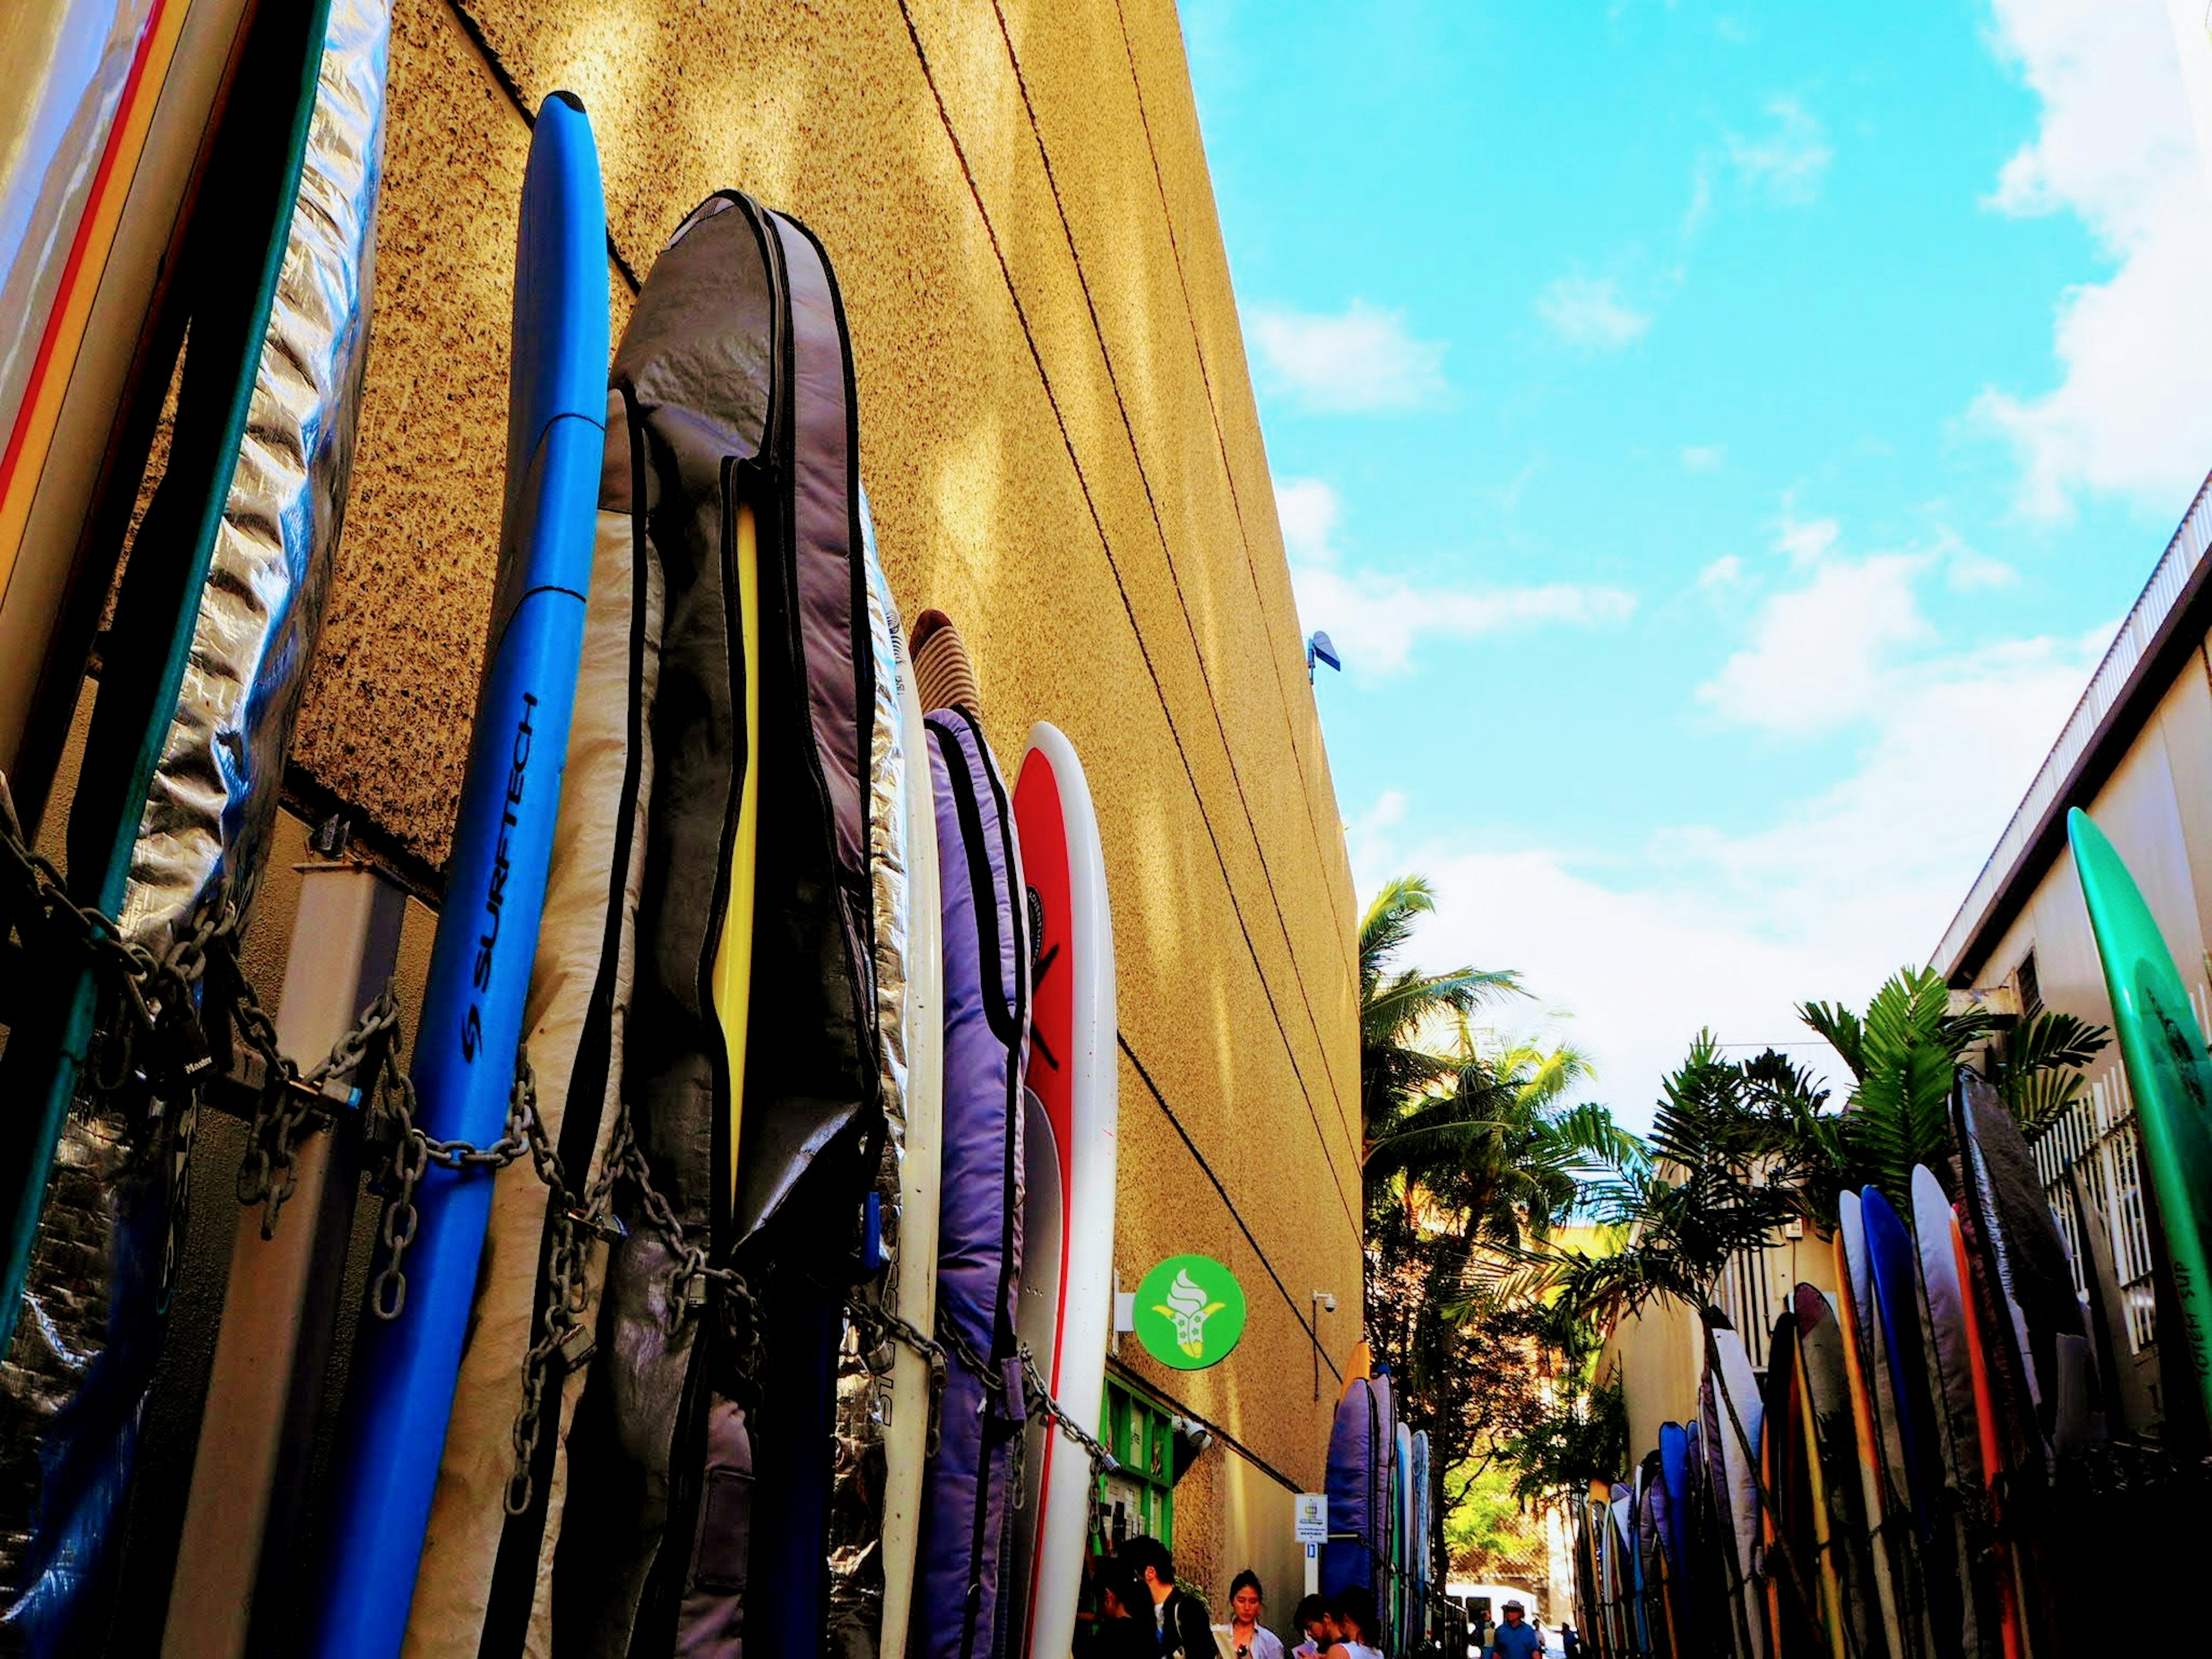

{"left": 0, "top": 0, "right": 1117, "bottom": 1659}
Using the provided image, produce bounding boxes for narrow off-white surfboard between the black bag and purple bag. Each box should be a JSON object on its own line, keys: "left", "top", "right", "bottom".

{"left": 878, "top": 646, "right": 945, "bottom": 1659}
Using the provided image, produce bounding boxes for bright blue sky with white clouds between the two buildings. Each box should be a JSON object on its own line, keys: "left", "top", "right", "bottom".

{"left": 1183, "top": 0, "right": 2212, "bottom": 1122}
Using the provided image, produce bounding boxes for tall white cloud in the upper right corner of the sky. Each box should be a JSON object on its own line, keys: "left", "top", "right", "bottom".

{"left": 1971, "top": 0, "right": 2212, "bottom": 518}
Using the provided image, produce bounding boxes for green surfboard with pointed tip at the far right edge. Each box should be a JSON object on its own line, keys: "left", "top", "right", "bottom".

{"left": 2066, "top": 809, "right": 2212, "bottom": 1416}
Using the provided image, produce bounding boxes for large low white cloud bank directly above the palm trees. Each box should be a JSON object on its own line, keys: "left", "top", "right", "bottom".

{"left": 1351, "top": 566, "right": 2110, "bottom": 1124}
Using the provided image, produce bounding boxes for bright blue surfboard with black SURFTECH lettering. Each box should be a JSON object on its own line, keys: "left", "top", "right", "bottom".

{"left": 312, "top": 93, "right": 608, "bottom": 1659}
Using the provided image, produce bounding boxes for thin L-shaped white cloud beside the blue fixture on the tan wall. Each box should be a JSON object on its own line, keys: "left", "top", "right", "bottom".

{"left": 1274, "top": 478, "right": 1637, "bottom": 675}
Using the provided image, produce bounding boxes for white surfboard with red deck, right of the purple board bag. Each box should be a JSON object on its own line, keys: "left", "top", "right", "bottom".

{"left": 1013, "top": 724, "right": 1119, "bottom": 1659}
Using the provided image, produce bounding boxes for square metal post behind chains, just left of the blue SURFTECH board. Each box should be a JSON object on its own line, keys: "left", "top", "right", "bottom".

{"left": 161, "top": 865, "right": 407, "bottom": 1659}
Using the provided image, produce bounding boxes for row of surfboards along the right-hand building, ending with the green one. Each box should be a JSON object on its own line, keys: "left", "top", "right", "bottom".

{"left": 1573, "top": 809, "right": 2212, "bottom": 1659}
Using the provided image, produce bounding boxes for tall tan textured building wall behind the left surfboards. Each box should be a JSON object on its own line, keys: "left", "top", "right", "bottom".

{"left": 297, "top": 0, "right": 1361, "bottom": 1615}
